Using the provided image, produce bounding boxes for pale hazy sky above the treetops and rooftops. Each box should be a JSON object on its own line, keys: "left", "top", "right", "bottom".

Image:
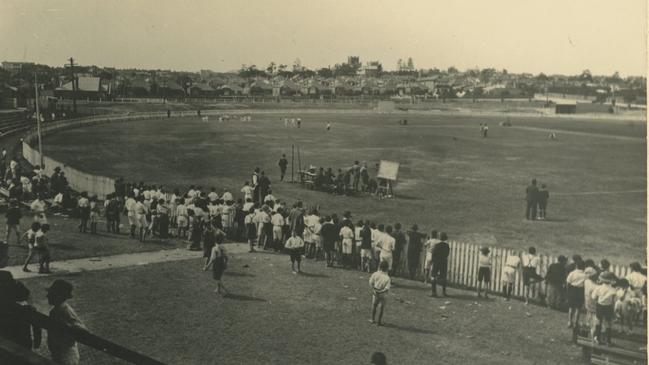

{"left": 0, "top": 0, "right": 647, "bottom": 75}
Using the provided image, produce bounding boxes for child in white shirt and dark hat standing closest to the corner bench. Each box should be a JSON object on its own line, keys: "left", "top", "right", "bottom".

{"left": 591, "top": 271, "right": 617, "bottom": 345}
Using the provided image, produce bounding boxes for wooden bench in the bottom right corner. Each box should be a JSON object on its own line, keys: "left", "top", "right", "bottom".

{"left": 577, "top": 336, "right": 647, "bottom": 365}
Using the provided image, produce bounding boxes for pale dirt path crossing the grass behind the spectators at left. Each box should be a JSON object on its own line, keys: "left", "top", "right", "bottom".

{"left": 2, "top": 243, "right": 248, "bottom": 279}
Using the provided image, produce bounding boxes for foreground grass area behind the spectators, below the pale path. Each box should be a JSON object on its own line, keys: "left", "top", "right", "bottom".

{"left": 25, "top": 245, "right": 580, "bottom": 364}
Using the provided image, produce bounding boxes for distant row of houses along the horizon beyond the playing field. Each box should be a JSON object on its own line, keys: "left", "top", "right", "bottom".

{"left": 54, "top": 75, "right": 528, "bottom": 99}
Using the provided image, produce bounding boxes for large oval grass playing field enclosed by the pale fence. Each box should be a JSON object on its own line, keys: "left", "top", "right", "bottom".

{"left": 44, "top": 112, "right": 646, "bottom": 264}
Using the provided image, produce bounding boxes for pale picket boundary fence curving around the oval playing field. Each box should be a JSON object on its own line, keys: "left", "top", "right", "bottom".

{"left": 17, "top": 110, "right": 628, "bottom": 298}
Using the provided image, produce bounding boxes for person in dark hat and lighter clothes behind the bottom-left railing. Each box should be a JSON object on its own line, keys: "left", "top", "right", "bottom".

{"left": 47, "top": 279, "right": 86, "bottom": 365}
